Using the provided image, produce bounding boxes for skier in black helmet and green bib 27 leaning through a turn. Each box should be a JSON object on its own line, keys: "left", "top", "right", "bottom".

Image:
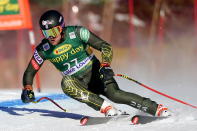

{"left": 21, "top": 10, "right": 170, "bottom": 116}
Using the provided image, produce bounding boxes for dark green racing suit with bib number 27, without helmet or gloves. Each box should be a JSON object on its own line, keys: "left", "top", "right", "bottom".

{"left": 23, "top": 26, "right": 158, "bottom": 115}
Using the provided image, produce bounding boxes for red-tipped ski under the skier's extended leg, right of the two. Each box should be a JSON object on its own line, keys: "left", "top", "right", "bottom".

{"left": 131, "top": 115, "right": 169, "bottom": 125}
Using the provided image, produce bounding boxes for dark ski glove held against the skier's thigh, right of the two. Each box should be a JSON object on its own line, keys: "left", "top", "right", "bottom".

{"left": 99, "top": 63, "right": 114, "bottom": 82}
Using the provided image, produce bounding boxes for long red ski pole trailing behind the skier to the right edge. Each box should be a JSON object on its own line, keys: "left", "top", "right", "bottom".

{"left": 115, "top": 74, "right": 197, "bottom": 108}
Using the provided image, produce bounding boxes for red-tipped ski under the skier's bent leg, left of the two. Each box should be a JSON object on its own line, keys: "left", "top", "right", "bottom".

{"left": 80, "top": 114, "right": 131, "bottom": 126}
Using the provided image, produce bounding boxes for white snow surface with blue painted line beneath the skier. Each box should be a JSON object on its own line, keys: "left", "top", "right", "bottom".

{"left": 0, "top": 90, "right": 197, "bottom": 131}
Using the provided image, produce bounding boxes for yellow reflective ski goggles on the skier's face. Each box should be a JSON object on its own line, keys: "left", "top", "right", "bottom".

{"left": 41, "top": 26, "right": 62, "bottom": 38}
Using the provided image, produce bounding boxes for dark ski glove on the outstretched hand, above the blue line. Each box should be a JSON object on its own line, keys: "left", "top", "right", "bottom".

{"left": 21, "top": 85, "right": 35, "bottom": 103}
